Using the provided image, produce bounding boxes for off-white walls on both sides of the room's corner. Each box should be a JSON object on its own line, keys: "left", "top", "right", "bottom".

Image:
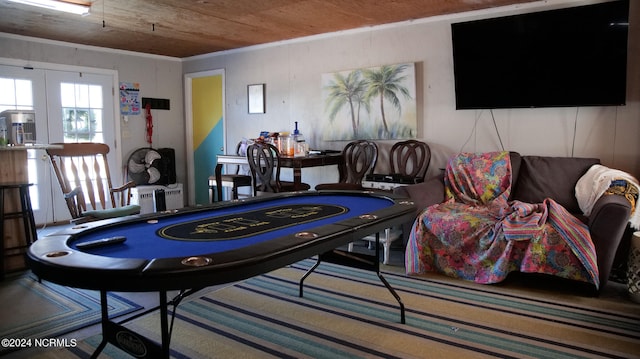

{"left": 0, "top": 0, "right": 640, "bottom": 197}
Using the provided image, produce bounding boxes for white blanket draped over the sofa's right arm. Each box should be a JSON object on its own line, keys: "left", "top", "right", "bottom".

{"left": 576, "top": 165, "right": 640, "bottom": 230}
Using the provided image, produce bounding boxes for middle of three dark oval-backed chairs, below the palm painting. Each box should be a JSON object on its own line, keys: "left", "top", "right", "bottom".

{"left": 315, "top": 140, "right": 378, "bottom": 190}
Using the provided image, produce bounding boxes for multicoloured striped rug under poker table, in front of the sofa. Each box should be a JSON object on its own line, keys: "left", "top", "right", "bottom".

{"left": 41, "top": 260, "right": 640, "bottom": 359}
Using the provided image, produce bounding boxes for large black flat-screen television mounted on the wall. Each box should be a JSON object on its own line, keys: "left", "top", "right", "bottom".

{"left": 451, "top": 0, "right": 629, "bottom": 109}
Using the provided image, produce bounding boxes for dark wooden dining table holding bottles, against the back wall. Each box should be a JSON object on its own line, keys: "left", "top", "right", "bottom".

{"left": 217, "top": 153, "right": 344, "bottom": 191}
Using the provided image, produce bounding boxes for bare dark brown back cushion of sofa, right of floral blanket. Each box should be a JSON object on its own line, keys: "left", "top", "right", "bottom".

{"left": 511, "top": 156, "right": 600, "bottom": 213}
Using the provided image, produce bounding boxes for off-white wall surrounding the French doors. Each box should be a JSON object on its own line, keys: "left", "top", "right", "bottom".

{"left": 0, "top": 34, "right": 186, "bottom": 188}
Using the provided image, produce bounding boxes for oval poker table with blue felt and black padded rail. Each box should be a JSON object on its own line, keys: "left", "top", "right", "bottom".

{"left": 27, "top": 191, "right": 415, "bottom": 357}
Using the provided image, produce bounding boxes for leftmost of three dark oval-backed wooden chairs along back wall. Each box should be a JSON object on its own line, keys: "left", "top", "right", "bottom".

{"left": 247, "top": 143, "right": 311, "bottom": 196}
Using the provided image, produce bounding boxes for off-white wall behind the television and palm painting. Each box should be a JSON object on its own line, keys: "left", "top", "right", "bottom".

{"left": 183, "top": 1, "right": 640, "bottom": 184}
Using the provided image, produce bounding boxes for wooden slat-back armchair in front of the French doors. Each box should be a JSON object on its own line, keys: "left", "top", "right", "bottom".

{"left": 47, "top": 142, "right": 140, "bottom": 223}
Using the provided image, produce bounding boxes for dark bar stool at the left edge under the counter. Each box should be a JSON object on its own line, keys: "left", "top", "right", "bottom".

{"left": 0, "top": 182, "right": 38, "bottom": 279}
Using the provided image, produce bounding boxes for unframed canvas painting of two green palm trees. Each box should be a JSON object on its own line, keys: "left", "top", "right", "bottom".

{"left": 322, "top": 63, "right": 417, "bottom": 141}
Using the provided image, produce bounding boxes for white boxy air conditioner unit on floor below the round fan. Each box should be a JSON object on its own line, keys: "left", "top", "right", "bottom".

{"left": 131, "top": 183, "right": 184, "bottom": 214}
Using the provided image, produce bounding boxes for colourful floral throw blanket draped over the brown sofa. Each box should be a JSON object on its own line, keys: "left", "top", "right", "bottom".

{"left": 405, "top": 152, "right": 599, "bottom": 288}
